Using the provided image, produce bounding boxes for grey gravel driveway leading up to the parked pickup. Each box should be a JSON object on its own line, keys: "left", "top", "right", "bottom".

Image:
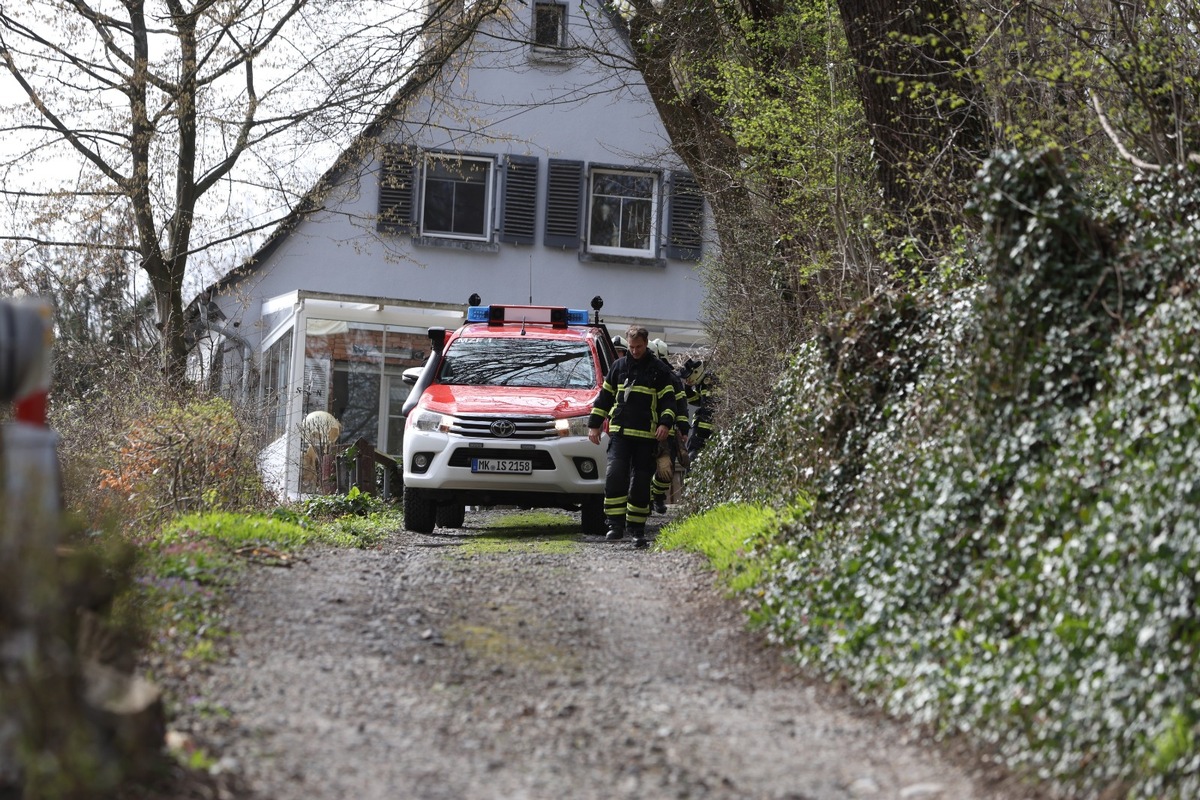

{"left": 152, "top": 511, "right": 1060, "bottom": 800}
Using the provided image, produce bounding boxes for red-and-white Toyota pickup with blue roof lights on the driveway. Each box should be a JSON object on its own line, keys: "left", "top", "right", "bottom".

{"left": 403, "top": 303, "right": 617, "bottom": 535}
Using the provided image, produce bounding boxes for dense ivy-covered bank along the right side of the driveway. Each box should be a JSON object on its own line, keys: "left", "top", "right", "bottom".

{"left": 689, "top": 154, "right": 1200, "bottom": 799}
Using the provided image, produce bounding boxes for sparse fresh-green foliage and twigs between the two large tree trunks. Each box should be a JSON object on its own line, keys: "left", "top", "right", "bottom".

{"left": 681, "top": 0, "right": 883, "bottom": 424}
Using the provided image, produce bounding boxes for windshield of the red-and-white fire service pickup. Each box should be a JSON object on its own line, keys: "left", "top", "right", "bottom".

{"left": 437, "top": 337, "right": 596, "bottom": 389}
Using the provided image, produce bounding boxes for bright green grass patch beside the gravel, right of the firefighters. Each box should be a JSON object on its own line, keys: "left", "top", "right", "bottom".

{"left": 655, "top": 503, "right": 805, "bottom": 594}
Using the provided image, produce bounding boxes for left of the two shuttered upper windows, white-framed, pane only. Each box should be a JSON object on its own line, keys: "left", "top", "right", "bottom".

{"left": 421, "top": 154, "right": 492, "bottom": 241}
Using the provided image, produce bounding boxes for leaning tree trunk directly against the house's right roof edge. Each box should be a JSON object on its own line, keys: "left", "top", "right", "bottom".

{"left": 629, "top": 0, "right": 814, "bottom": 411}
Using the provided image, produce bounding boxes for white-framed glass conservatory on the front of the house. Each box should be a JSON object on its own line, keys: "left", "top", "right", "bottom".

{"left": 197, "top": 291, "right": 466, "bottom": 499}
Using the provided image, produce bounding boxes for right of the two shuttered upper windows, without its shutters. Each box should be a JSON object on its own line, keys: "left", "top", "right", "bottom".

{"left": 588, "top": 169, "right": 658, "bottom": 257}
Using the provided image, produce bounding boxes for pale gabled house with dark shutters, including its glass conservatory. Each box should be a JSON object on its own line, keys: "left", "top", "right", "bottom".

{"left": 190, "top": 0, "right": 712, "bottom": 495}
